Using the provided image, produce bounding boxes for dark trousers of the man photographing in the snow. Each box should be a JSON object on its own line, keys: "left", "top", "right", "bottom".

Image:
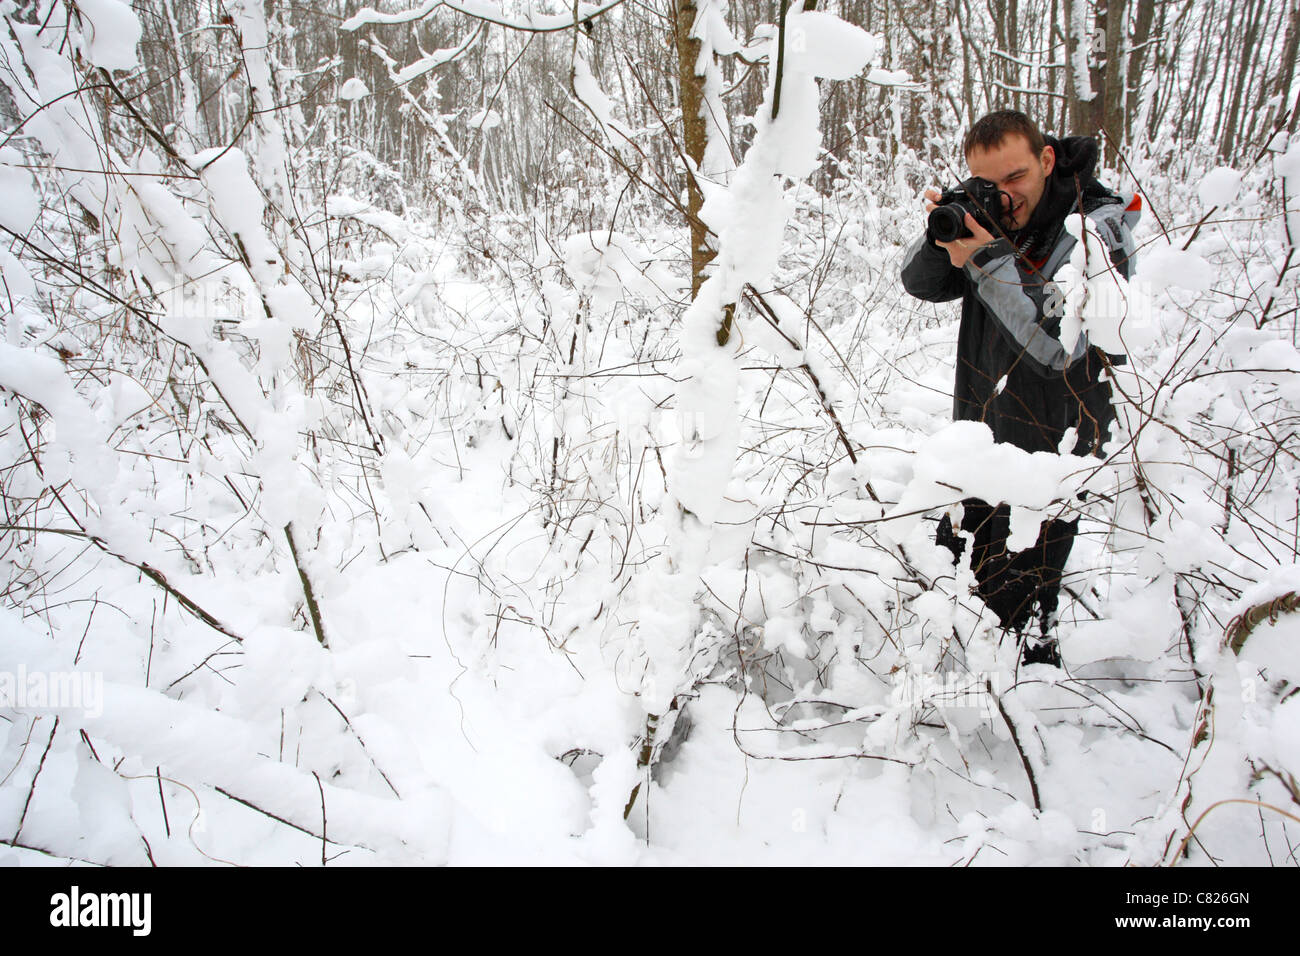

{"left": 935, "top": 498, "right": 1079, "bottom": 636}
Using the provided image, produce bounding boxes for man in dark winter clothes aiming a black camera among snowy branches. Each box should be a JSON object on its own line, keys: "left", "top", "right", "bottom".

{"left": 902, "top": 111, "right": 1140, "bottom": 666}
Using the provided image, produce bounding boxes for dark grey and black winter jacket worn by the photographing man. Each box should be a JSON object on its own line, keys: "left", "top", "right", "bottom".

{"left": 902, "top": 137, "right": 1139, "bottom": 454}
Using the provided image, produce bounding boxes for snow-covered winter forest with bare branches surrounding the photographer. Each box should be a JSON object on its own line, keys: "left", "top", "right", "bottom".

{"left": 0, "top": 0, "right": 1300, "bottom": 866}
